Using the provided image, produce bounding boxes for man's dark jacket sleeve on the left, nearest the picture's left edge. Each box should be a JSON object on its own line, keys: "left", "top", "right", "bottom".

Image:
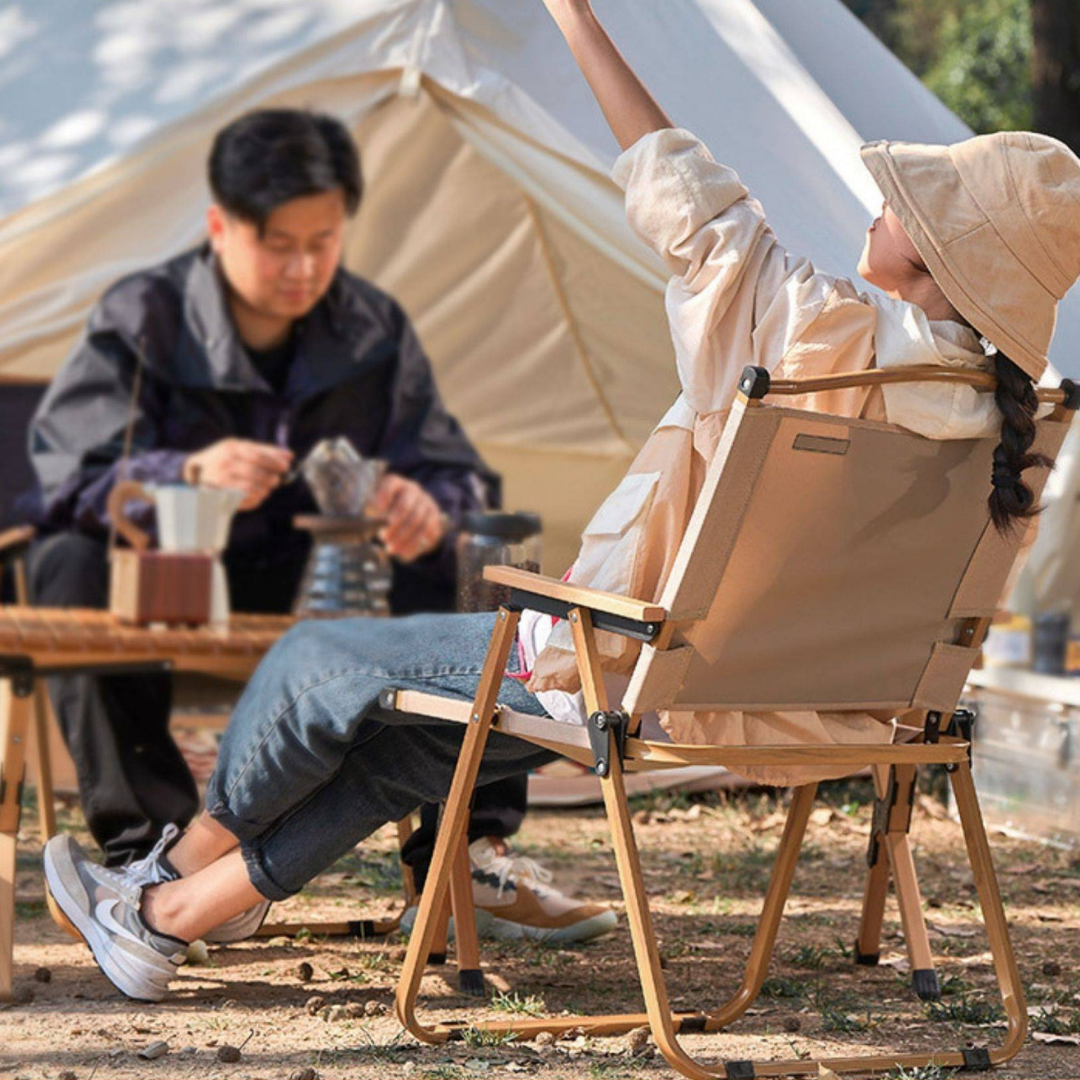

{"left": 29, "top": 321, "right": 187, "bottom": 535}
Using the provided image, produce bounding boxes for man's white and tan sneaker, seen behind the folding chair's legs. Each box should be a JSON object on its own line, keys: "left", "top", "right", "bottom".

{"left": 402, "top": 836, "right": 619, "bottom": 945}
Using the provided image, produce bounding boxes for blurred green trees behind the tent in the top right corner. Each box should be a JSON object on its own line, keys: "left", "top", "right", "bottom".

{"left": 845, "top": 0, "right": 1080, "bottom": 152}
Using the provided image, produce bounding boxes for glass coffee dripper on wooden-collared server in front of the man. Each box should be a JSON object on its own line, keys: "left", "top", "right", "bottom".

{"left": 293, "top": 438, "right": 393, "bottom": 619}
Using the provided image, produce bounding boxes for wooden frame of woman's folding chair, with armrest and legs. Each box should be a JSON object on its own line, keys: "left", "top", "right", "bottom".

{"left": 381, "top": 368, "right": 1080, "bottom": 1080}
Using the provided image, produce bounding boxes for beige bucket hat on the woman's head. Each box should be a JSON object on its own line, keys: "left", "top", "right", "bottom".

{"left": 862, "top": 132, "right": 1080, "bottom": 379}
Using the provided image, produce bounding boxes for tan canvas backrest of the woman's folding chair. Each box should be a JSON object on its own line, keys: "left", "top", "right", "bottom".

{"left": 623, "top": 397, "right": 1072, "bottom": 713}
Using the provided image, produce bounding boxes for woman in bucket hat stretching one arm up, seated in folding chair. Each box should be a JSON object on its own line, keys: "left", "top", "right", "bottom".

{"left": 45, "top": 0, "right": 1080, "bottom": 1001}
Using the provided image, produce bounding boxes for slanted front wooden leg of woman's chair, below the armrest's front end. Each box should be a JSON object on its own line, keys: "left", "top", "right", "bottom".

{"left": 394, "top": 608, "right": 518, "bottom": 1042}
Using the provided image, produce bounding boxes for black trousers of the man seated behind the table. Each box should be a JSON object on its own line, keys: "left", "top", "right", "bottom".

{"left": 29, "top": 532, "right": 527, "bottom": 879}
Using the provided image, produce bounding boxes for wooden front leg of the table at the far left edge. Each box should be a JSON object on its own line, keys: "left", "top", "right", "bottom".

{"left": 0, "top": 678, "right": 33, "bottom": 1001}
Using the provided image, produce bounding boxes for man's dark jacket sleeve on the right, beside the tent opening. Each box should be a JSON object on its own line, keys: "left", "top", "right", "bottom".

{"left": 379, "top": 295, "right": 501, "bottom": 576}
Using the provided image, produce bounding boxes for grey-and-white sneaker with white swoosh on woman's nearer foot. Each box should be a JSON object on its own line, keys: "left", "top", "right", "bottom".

{"left": 44, "top": 835, "right": 188, "bottom": 1001}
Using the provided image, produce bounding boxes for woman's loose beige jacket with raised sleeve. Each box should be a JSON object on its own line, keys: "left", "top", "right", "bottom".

{"left": 528, "top": 130, "right": 1032, "bottom": 783}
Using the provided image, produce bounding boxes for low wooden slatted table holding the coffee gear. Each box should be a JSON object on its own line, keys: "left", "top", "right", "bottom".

{"left": 0, "top": 606, "right": 294, "bottom": 1001}
